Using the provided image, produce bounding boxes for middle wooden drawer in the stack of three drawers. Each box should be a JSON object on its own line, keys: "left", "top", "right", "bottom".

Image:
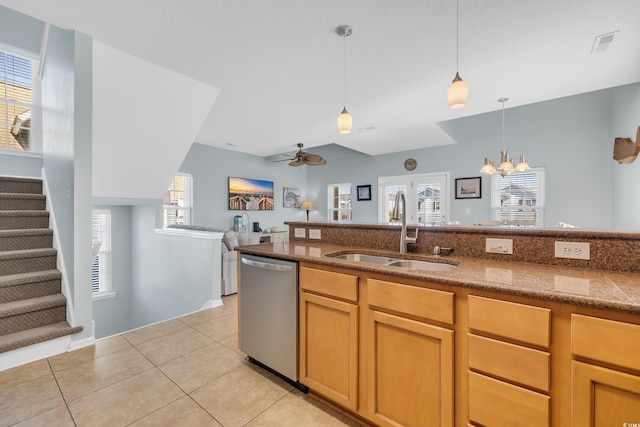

{"left": 469, "top": 335, "right": 550, "bottom": 392}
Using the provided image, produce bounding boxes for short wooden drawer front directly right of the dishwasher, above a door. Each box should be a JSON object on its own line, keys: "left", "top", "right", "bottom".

{"left": 300, "top": 267, "right": 358, "bottom": 302}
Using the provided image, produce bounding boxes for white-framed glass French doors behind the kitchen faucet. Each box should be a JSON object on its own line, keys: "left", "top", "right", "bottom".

{"left": 378, "top": 172, "right": 449, "bottom": 225}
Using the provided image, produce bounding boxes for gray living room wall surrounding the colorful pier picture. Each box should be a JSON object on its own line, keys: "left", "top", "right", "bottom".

{"left": 180, "top": 143, "right": 310, "bottom": 229}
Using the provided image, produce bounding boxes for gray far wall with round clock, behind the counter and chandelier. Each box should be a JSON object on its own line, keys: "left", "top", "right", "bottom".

{"left": 307, "top": 85, "right": 616, "bottom": 228}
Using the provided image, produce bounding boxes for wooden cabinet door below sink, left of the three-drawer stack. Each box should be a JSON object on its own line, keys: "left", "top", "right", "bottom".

{"left": 367, "top": 310, "right": 453, "bottom": 427}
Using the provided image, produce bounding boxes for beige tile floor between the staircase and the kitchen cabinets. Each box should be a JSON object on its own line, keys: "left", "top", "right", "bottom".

{"left": 0, "top": 295, "right": 359, "bottom": 427}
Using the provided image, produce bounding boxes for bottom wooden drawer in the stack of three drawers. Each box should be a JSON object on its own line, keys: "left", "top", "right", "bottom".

{"left": 469, "top": 372, "right": 550, "bottom": 427}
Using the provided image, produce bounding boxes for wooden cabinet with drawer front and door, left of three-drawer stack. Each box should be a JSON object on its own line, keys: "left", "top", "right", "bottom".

{"left": 366, "top": 279, "right": 454, "bottom": 427}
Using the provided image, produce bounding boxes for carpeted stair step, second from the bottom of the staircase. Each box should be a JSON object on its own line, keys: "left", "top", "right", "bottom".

{"left": 0, "top": 294, "right": 67, "bottom": 335}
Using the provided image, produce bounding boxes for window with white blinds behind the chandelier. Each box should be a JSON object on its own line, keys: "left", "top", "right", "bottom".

{"left": 491, "top": 168, "right": 544, "bottom": 227}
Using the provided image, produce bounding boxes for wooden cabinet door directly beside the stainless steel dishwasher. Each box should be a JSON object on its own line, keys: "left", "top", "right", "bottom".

{"left": 300, "top": 291, "right": 358, "bottom": 411}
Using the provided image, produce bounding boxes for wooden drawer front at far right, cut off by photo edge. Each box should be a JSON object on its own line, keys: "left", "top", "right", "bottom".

{"left": 571, "top": 314, "right": 640, "bottom": 371}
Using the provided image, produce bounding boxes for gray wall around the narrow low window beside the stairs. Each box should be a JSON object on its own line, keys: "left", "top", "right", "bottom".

{"left": 93, "top": 206, "right": 132, "bottom": 338}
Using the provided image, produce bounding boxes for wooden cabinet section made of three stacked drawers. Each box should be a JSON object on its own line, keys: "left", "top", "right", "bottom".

{"left": 468, "top": 295, "right": 551, "bottom": 427}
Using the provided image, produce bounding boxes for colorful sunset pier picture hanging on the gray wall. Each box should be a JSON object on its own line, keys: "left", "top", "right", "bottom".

{"left": 228, "top": 177, "right": 273, "bottom": 211}
